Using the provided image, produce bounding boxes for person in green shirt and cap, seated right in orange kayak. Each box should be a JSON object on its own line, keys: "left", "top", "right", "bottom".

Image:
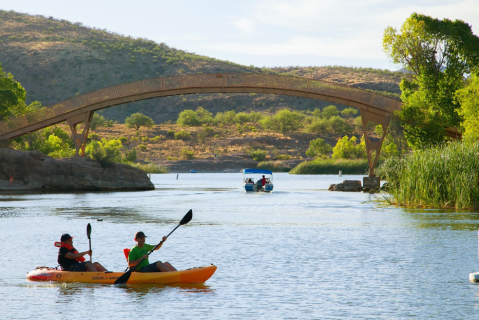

{"left": 128, "top": 231, "right": 177, "bottom": 272}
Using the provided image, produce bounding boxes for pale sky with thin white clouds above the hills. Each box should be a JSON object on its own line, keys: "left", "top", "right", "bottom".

{"left": 0, "top": 0, "right": 479, "bottom": 70}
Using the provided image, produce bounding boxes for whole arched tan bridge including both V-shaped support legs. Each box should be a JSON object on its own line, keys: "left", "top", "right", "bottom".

{"left": 0, "top": 73, "right": 402, "bottom": 176}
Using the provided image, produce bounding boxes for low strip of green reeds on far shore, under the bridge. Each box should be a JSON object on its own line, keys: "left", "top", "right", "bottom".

{"left": 289, "top": 159, "right": 369, "bottom": 174}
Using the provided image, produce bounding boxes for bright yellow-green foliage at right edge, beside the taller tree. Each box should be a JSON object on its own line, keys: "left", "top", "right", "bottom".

{"left": 456, "top": 74, "right": 479, "bottom": 140}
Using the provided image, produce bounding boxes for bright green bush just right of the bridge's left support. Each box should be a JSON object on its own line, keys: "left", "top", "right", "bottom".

{"left": 85, "top": 139, "right": 123, "bottom": 167}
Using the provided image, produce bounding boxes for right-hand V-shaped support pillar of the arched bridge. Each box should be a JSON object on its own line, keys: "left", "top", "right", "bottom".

{"left": 360, "top": 110, "right": 391, "bottom": 182}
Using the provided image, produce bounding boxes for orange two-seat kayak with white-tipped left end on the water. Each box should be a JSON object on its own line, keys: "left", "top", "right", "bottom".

{"left": 27, "top": 265, "right": 216, "bottom": 284}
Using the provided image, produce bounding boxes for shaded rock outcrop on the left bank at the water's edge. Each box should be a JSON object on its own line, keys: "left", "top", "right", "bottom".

{"left": 0, "top": 148, "right": 155, "bottom": 191}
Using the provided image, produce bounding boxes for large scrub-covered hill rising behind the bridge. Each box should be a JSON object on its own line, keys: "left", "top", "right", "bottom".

{"left": 0, "top": 10, "right": 403, "bottom": 123}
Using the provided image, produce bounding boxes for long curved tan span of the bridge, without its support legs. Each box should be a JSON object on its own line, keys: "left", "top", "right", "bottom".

{"left": 0, "top": 73, "right": 401, "bottom": 136}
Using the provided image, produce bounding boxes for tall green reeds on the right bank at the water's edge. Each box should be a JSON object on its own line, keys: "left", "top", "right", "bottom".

{"left": 376, "top": 141, "right": 479, "bottom": 209}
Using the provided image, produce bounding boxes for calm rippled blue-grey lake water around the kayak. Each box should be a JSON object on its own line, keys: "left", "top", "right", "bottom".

{"left": 0, "top": 173, "right": 479, "bottom": 319}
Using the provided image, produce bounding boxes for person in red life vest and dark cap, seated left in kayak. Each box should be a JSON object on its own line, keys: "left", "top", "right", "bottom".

{"left": 58, "top": 233, "right": 108, "bottom": 272}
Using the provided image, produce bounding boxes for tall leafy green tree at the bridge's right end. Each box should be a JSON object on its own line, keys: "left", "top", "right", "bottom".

{"left": 383, "top": 13, "right": 479, "bottom": 148}
